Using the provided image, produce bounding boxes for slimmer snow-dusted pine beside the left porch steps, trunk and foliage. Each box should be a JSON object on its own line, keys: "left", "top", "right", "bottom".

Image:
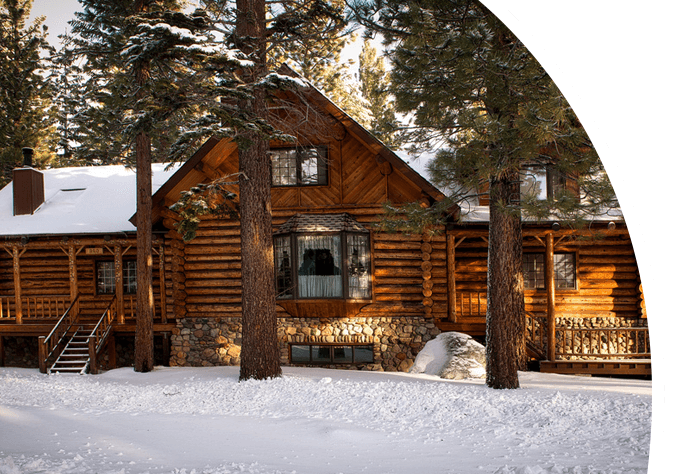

{"left": 64, "top": 0, "right": 256, "bottom": 372}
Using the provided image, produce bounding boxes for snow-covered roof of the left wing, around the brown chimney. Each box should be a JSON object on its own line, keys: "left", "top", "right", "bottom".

{"left": 0, "top": 163, "right": 179, "bottom": 237}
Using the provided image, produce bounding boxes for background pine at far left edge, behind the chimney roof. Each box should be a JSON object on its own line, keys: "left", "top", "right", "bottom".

{"left": 0, "top": 0, "right": 55, "bottom": 186}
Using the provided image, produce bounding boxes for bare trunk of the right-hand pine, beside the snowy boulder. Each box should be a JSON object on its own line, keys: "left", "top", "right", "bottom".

{"left": 486, "top": 174, "right": 526, "bottom": 389}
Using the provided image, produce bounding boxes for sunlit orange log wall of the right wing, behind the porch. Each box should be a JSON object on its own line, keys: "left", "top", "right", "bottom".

{"left": 445, "top": 227, "right": 645, "bottom": 336}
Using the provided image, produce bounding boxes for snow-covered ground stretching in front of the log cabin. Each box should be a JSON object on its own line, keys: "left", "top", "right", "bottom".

{"left": 0, "top": 367, "right": 652, "bottom": 474}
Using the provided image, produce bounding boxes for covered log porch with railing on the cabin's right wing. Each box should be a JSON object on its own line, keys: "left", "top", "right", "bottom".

{"left": 437, "top": 225, "right": 651, "bottom": 376}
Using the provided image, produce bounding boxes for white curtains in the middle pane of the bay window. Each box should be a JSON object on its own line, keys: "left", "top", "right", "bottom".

{"left": 297, "top": 235, "right": 342, "bottom": 298}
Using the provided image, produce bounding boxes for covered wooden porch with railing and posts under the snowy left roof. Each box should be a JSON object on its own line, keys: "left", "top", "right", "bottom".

{"left": 0, "top": 235, "right": 175, "bottom": 371}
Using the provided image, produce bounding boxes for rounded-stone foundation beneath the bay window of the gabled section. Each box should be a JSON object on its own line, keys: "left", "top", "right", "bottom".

{"left": 170, "top": 316, "right": 440, "bottom": 372}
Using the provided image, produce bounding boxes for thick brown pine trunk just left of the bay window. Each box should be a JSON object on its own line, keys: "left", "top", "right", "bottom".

{"left": 237, "top": 0, "right": 281, "bottom": 380}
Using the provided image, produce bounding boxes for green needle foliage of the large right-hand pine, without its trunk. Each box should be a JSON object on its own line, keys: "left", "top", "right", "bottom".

{"left": 352, "top": 0, "right": 618, "bottom": 223}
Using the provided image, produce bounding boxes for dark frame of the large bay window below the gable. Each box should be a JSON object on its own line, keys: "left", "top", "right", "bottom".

{"left": 273, "top": 231, "right": 374, "bottom": 301}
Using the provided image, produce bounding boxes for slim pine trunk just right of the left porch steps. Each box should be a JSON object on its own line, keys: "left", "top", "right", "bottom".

{"left": 134, "top": 0, "right": 155, "bottom": 372}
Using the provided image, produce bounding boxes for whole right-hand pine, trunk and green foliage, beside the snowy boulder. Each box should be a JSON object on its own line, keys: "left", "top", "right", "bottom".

{"left": 353, "top": 0, "right": 614, "bottom": 388}
